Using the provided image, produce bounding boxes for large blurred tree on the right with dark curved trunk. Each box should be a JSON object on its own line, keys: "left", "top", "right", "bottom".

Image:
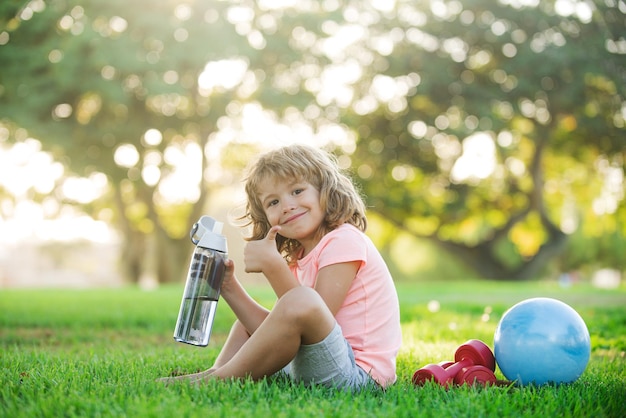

{"left": 322, "top": 0, "right": 626, "bottom": 279}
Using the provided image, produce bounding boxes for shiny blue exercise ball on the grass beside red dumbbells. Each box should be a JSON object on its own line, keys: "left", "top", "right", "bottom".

{"left": 494, "top": 298, "right": 591, "bottom": 385}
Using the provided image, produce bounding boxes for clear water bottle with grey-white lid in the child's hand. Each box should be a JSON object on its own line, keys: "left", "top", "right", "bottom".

{"left": 174, "top": 216, "right": 227, "bottom": 347}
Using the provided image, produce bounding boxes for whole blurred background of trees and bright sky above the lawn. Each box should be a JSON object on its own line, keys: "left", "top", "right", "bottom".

{"left": 0, "top": 0, "right": 626, "bottom": 288}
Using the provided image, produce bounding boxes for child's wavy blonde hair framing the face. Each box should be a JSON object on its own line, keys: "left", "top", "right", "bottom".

{"left": 240, "top": 144, "right": 367, "bottom": 263}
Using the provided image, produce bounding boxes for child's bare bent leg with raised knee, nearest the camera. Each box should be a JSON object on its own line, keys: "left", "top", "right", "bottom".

{"left": 203, "top": 287, "right": 335, "bottom": 379}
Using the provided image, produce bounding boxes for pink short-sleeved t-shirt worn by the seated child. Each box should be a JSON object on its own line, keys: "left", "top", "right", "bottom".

{"left": 291, "top": 224, "right": 402, "bottom": 387}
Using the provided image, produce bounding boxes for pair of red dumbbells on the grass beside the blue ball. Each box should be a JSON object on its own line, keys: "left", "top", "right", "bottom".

{"left": 413, "top": 340, "right": 496, "bottom": 387}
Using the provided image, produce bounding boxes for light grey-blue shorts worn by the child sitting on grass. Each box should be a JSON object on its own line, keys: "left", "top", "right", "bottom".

{"left": 282, "top": 323, "right": 378, "bottom": 390}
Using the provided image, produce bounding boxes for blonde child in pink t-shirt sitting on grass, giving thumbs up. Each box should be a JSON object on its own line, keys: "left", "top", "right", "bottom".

{"left": 163, "top": 145, "right": 401, "bottom": 390}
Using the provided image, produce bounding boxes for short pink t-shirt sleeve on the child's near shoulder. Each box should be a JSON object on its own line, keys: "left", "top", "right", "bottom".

{"left": 318, "top": 228, "right": 367, "bottom": 269}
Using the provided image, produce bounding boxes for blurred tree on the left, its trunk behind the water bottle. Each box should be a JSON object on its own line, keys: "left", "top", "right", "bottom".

{"left": 0, "top": 0, "right": 258, "bottom": 281}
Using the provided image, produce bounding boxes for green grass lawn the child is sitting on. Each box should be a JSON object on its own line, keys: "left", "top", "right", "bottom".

{"left": 0, "top": 282, "right": 626, "bottom": 418}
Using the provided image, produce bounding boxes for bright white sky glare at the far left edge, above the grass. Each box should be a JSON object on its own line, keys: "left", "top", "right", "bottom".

{"left": 0, "top": 138, "right": 114, "bottom": 246}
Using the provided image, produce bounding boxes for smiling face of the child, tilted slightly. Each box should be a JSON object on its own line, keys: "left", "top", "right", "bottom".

{"left": 259, "top": 179, "right": 325, "bottom": 252}
